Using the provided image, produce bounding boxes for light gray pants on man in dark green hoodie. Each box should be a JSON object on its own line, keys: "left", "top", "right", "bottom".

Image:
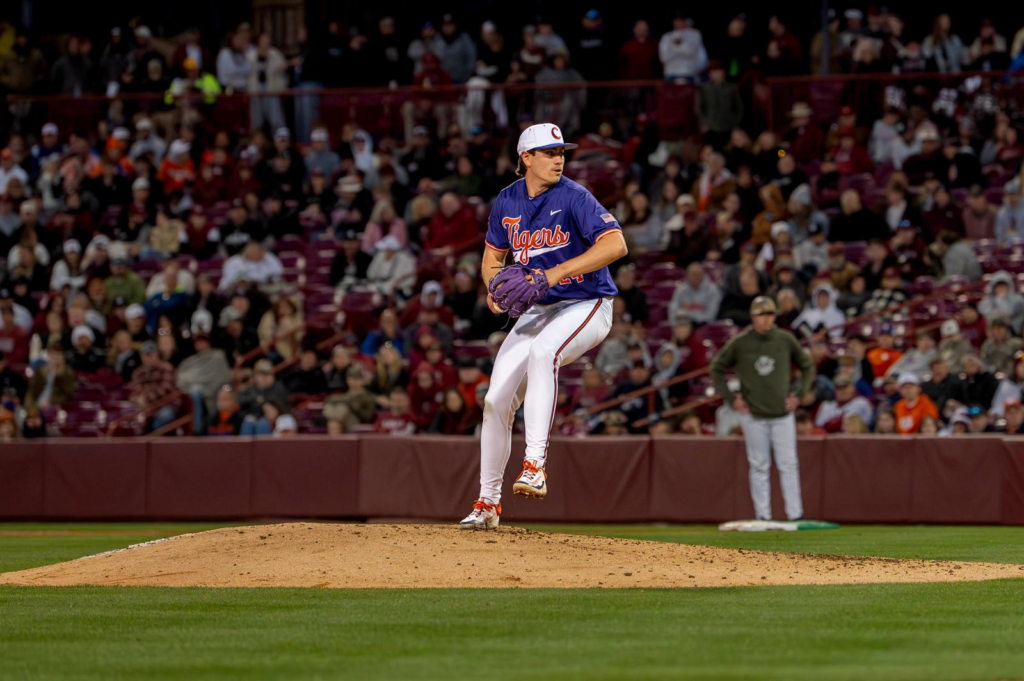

{"left": 741, "top": 414, "right": 804, "bottom": 520}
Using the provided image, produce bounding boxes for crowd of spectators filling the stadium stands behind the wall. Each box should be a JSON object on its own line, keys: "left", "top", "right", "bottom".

{"left": 0, "top": 10, "right": 1024, "bottom": 438}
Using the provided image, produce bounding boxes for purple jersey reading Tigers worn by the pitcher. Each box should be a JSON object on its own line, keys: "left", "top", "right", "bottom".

{"left": 486, "top": 176, "right": 622, "bottom": 305}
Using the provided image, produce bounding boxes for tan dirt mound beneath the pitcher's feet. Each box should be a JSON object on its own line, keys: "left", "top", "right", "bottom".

{"left": 0, "top": 523, "right": 1024, "bottom": 589}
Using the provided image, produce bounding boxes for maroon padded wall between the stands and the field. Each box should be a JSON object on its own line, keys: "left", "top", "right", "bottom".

{"left": 6, "top": 435, "right": 1024, "bottom": 524}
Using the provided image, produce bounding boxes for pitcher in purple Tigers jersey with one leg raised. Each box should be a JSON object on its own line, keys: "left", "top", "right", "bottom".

{"left": 461, "top": 123, "right": 626, "bottom": 529}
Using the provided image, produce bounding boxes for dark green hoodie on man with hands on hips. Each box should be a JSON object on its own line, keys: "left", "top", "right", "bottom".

{"left": 711, "top": 328, "right": 814, "bottom": 419}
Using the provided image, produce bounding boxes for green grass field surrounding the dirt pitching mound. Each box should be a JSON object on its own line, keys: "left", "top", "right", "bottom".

{"left": 0, "top": 523, "right": 1024, "bottom": 679}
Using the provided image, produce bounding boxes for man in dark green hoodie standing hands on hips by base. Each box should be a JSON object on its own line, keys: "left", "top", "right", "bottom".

{"left": 711, "top": 296, "right": 814, "bottom": 520}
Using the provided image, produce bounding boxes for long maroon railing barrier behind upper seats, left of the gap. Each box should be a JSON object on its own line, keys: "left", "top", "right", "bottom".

{"left": 6, "top": 80, "right": 671, "bottom": 142}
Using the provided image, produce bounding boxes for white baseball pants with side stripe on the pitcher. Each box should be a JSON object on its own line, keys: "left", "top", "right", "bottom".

{"left": 480, "top": 298, "right": 611, "bottom": 504}
